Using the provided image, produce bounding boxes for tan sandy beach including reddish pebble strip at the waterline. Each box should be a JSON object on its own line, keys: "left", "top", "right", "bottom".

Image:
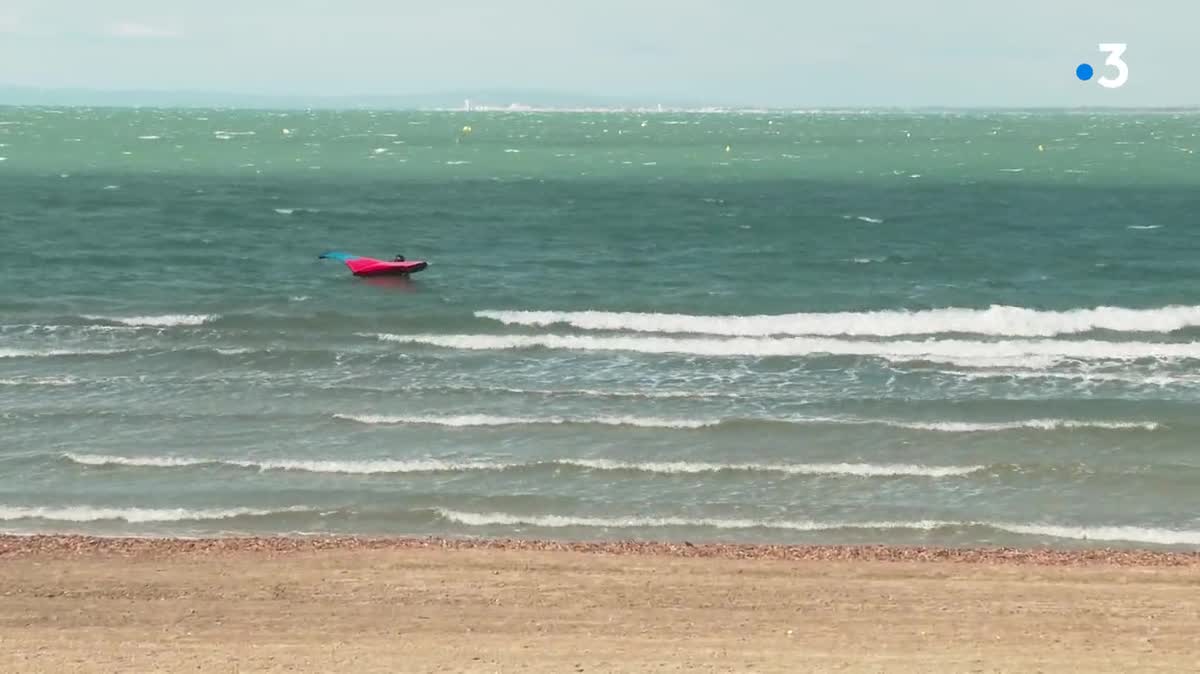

{"left": 0, "top": 536, "right": 1200, "bottom": 673}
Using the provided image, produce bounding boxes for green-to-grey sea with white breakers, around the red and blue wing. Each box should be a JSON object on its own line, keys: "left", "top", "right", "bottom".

{"left": 0, "top": 107, "right": 1200, "bottom": 549}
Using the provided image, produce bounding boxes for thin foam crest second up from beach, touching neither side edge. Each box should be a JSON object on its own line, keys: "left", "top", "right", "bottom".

{"left": 64, "top": 453, "right": 986, "bottom": 477}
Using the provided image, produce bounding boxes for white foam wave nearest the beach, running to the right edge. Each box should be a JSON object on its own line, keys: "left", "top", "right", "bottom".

{"left": 437, "top": 508, "right": 1200, "bottom": 544}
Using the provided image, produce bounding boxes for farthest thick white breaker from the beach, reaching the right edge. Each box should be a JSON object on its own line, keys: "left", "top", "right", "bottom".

{"left": 475, "top": 305, "right": 1200, "bottom": 337}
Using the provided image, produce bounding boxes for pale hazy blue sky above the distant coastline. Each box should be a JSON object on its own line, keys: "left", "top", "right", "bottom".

{"left": 0, "top": 0, "right": 1200, "bottom": 107}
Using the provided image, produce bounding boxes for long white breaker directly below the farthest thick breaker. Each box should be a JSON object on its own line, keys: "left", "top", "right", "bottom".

{"left": 374, "top": 333, "right": 1200, "bottom": 368}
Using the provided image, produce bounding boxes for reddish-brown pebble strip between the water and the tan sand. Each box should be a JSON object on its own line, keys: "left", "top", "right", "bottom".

{"left": 0, "top": 535, "right": 1200, "bottom": 566}
